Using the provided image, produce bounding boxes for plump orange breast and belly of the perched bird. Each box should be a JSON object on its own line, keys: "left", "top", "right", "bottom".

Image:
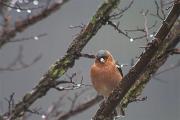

{"left": 90, "top": 64, "right": 122, "bottom": 97}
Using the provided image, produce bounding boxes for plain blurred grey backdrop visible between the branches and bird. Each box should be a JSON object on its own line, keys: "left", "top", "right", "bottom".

{"left": 0, "top": 0, "right": 180, "bottom": 120}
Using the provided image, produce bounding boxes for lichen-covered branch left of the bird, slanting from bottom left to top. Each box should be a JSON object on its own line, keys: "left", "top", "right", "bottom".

{"left": 9, "top": 0, "right": 120, "bottom": 120}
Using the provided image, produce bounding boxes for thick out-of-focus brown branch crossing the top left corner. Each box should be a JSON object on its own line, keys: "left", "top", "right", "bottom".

{"left": 0, "top": 0, "right": 69, "bottom": 48}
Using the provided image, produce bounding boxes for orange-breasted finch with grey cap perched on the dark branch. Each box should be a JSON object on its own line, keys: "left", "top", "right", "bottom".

{"left": 90, "top": 50, "right": 125, "bottom": 116}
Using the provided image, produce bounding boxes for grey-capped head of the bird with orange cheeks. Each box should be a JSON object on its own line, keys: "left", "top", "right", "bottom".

{"left": 95, "top": 50, "right": 114, "bottom": 64}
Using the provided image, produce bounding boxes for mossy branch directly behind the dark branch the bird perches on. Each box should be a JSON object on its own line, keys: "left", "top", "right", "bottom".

{"left": 121, "top": 22, "right": 180, "bottom": 108}
